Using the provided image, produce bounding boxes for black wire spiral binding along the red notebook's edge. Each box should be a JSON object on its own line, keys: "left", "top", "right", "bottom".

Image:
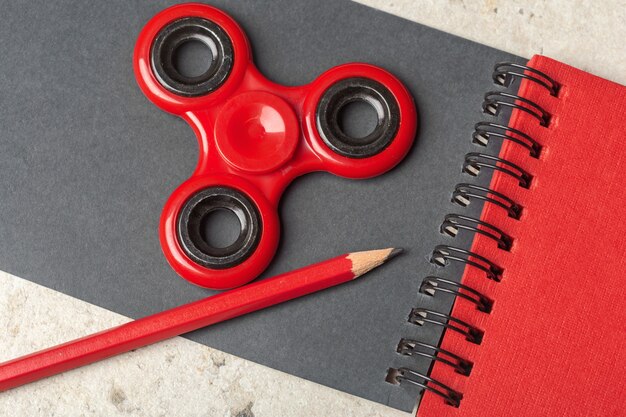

{"left": 386, "top": 62, "right": 560, "bottom": 407}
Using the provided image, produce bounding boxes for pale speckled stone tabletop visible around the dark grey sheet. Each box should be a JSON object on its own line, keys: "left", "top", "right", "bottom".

{"left": 0, "top": 0, "right": 626, "bottom": 417}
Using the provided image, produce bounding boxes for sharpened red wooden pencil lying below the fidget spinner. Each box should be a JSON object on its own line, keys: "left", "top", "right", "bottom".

{"left": 0, "top": 249, "right": 400, "bottom": 391}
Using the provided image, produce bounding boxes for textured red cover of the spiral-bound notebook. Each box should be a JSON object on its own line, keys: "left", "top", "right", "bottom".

{"left": 417, "top": 56, "right": 626, "bottom": 417}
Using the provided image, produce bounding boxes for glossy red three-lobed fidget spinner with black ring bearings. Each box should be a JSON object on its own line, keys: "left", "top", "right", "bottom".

{"left": 133, "top": 3, "right": 417, "bottom": 289}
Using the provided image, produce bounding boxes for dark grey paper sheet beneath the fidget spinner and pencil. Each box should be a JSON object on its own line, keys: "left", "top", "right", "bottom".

{"left": 0, "top": 0, "right": 515, "bottom": 411}
